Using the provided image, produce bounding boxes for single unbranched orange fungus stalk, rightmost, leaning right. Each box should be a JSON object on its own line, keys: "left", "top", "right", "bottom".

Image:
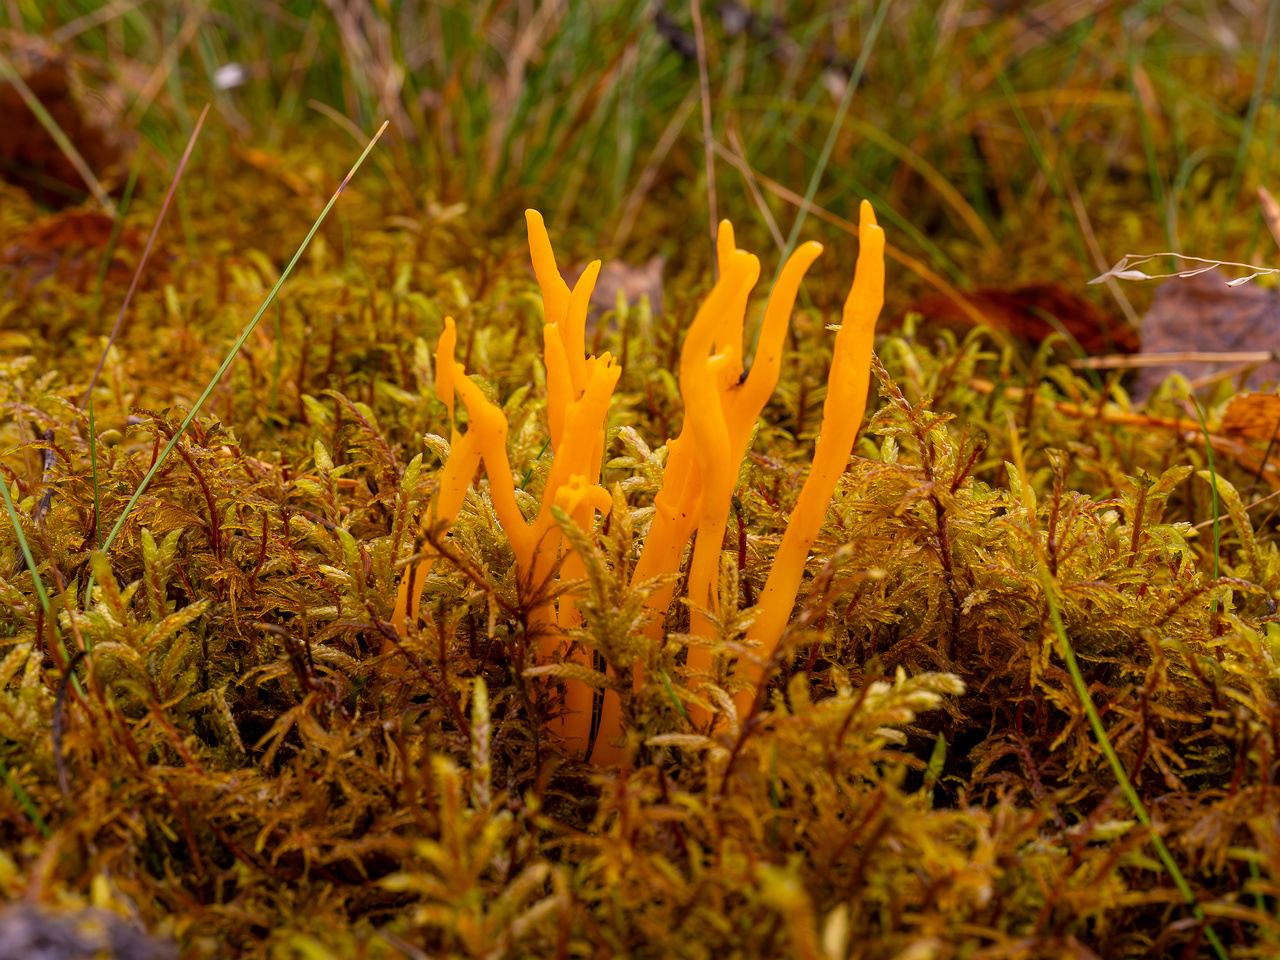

{"left": 739, "top": 200, "right": 884, "bottom": 710}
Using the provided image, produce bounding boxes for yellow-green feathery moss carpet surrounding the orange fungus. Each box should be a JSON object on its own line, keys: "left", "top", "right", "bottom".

{"left": 0, "top": 140, "right": 1280, "bottom": 957}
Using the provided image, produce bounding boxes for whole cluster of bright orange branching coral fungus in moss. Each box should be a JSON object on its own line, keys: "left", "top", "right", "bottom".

{"left": 396, "top": 202, "right": 884, "bottom": 763}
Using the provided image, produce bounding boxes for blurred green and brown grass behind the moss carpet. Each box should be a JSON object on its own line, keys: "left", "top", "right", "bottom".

{"left": 0, "top": 0, "right": 1280, "bottom": 317}
